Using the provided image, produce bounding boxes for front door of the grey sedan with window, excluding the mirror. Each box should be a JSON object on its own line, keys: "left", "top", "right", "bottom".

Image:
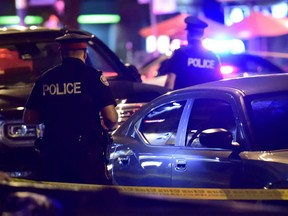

{"left": 172, "top": 98, "right": 242, "bottom": 188}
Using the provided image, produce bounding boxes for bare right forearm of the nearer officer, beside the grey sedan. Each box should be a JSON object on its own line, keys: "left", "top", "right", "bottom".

{"left": 101, "top": 105, "right": 118, "bottom": 130}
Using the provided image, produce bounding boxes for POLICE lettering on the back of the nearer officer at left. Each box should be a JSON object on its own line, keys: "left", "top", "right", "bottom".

{"left": 43, "top": 82, "right": 81, "bottom": 96}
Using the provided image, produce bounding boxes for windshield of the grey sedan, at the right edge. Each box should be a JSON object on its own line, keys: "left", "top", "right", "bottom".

{"left": 250, "top": 92, "right": 288, "bottom": 151}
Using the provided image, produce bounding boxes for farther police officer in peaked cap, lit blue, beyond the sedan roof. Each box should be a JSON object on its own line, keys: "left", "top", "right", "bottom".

{"left": 162, "top": 16, "right": 222, "bottom": 89}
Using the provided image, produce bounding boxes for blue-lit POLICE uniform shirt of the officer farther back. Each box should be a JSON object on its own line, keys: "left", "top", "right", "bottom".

{"left": 165, "top": 42, "right": 222, "bottom": 89}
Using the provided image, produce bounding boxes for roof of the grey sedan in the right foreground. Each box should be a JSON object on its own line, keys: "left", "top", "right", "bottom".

{"left": 172, "top": 73, "right": 288, "bottom": 95}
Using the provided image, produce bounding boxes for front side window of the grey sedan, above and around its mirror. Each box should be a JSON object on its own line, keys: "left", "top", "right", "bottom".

{"left": 186, "top": 99, "right": 236, "bottom": 148}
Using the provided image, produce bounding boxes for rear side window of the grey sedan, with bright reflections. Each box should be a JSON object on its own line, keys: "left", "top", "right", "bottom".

{"left": 139, "top": 101, "right": 186, "bottom": 145}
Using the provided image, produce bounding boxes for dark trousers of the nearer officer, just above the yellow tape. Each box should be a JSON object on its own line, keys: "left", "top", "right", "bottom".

{"left": 41, "top": 138, "right": 108, "bottom": 184}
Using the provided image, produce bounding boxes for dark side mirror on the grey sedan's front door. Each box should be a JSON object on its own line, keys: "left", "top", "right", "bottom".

{"left": 199, "top": 128, "right": 233, "bottom": 149}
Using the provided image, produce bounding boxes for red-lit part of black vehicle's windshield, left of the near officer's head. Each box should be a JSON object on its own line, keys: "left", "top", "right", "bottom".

{"left": 0, "top": 42, "right": 61, "bottom": 85}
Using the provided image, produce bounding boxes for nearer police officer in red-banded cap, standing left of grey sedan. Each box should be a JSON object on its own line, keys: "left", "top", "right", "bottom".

{"left": 23, "top": 33, "right": 118, "bottom": 184}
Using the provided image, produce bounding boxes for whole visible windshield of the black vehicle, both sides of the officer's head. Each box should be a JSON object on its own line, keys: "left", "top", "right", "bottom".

{"left": 0, "top": 41, "right": 118, "bottom": 86}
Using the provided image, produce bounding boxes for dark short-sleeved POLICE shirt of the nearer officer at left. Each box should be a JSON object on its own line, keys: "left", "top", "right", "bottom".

{"left": 26, "top": 58, "right": 116, "bottom": 147}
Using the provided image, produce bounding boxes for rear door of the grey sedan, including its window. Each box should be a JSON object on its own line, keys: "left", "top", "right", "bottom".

{"left": 113, "top": 101, "right": 186, "bottom": 187}
